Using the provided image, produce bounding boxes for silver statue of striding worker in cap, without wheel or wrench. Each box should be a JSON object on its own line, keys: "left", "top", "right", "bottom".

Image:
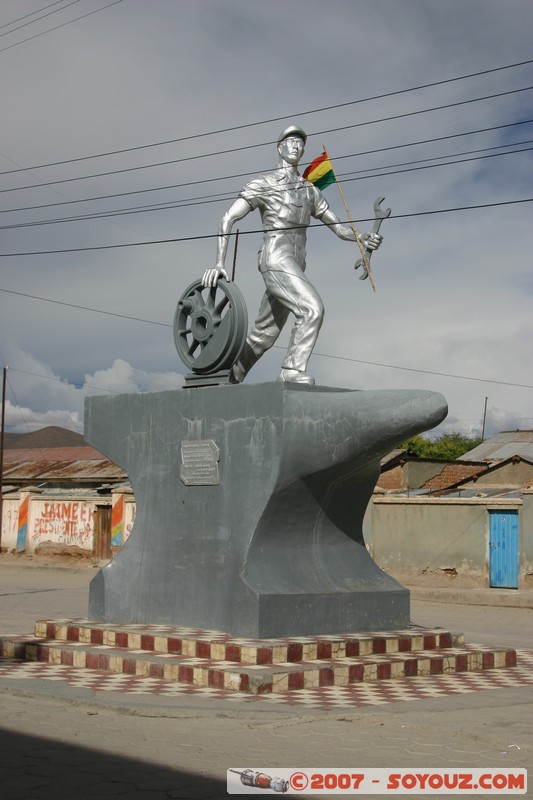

{"left": 202, "top": 125, "right": 382, "bottom": 384}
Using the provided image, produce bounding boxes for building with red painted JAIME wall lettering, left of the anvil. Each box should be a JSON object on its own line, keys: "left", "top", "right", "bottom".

{"left": 1, "top": 427, "right": 135, "bottom": 559}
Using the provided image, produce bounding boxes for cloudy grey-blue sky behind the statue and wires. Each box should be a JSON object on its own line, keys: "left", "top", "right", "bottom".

{"left": 0, "top": 0, "right": 533, "bottom": 437}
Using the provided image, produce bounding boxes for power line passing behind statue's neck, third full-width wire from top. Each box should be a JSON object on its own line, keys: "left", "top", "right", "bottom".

{"left": 4, "top": 119, "right": 533, "bottom": 214}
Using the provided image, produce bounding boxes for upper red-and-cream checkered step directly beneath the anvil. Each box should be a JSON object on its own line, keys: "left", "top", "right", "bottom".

{"left": 30, "top": 620, "right": 464, "bottom": 665}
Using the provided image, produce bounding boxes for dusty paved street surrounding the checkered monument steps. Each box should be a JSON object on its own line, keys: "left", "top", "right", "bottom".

{"left": 0, "top": 559, "right": 533, "bottom": 800}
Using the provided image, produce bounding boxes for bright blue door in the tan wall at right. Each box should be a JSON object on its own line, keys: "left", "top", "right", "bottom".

{"left": 489, "top": 511, "right": 518, "bottom": 589}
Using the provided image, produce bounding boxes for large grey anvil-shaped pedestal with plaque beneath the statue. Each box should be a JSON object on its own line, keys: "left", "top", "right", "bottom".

{"left": 85, "top": 382, "right": 447, "bottom": 638}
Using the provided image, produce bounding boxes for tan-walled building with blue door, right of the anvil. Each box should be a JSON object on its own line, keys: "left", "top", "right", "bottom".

{"left": 364, "top": 431, "right": 533, "bottom": 589}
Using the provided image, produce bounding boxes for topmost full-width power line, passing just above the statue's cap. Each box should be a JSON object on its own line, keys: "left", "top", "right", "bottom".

{"left": 0, "top": 55, "right": 533, "bottom": 175}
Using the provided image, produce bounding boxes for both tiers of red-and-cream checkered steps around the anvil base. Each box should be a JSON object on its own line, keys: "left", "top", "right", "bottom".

{"left": 0, "top": 620, "right": 516, "bottom": 694}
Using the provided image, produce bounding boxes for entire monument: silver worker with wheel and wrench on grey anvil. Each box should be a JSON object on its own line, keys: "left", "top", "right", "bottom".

{"left": 85, "top": 125, "right": 447, "bottom": 639}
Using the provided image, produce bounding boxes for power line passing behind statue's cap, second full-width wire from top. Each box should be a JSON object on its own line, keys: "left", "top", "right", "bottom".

{"left": 0, "top": 85, "right": 533, "bottom": 194}
